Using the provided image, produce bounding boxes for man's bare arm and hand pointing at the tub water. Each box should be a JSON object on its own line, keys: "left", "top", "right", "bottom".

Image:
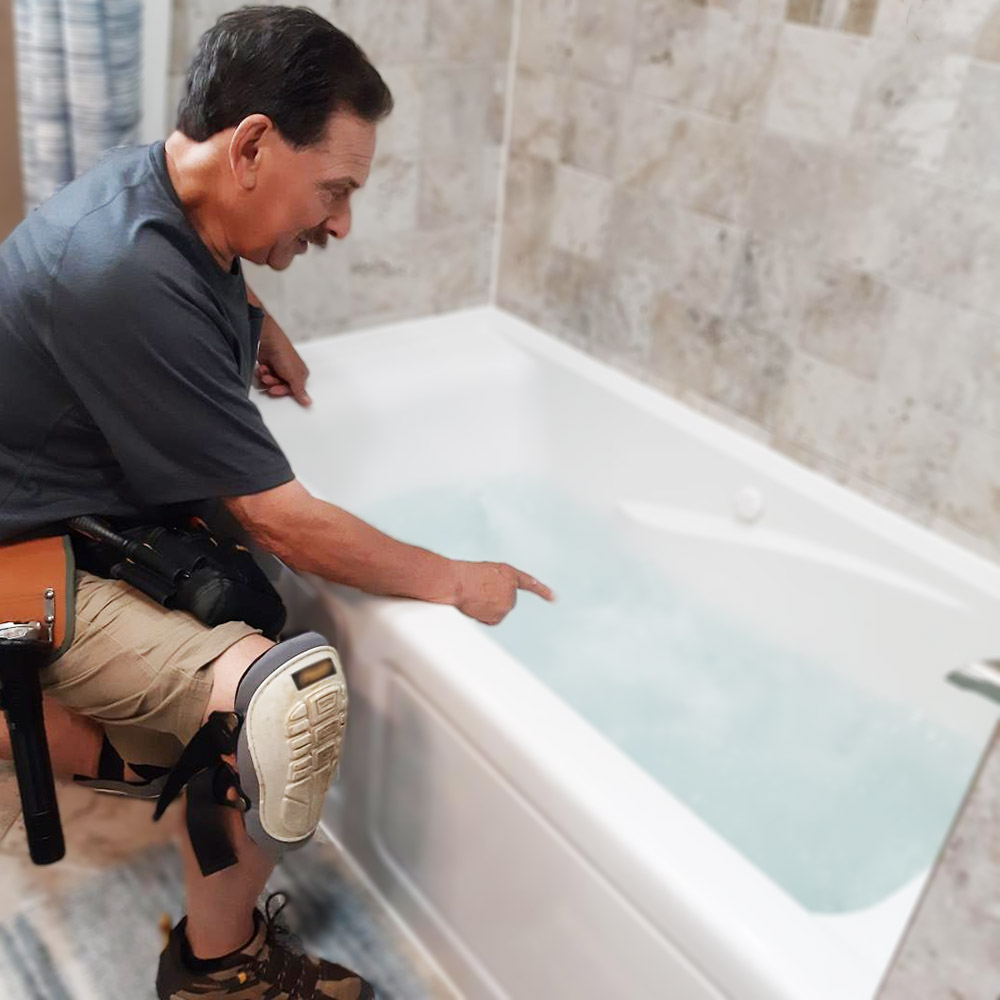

{"left": 225, "top": 480, "right": 553, "bottom": 625}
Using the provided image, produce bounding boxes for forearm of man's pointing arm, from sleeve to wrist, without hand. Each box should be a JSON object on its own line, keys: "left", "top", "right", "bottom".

{"left": 234, "top": 488, "right": 460, "bottom": 604}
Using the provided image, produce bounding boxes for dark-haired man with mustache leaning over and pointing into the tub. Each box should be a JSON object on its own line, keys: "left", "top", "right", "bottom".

{"left": 0, "top": 7, "right": 551, "bottom": 1000}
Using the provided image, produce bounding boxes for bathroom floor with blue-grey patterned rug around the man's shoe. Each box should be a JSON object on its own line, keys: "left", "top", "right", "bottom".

{"left": 0, "top": 762, "right": 453, "bottom": 1000}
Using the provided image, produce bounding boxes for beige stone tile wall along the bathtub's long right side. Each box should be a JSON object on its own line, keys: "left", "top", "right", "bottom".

{"left": 498, "top": 0, "right": 1000, "bottom": 559}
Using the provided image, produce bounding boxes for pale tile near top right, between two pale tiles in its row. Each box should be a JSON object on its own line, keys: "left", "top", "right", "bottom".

{"left": 854, "top": 38, "right": 969, "bottom": 171}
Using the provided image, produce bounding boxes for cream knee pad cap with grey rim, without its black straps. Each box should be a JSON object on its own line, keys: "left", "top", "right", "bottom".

{"left": 235, "top": 632, "right": 347, "bottom": 857}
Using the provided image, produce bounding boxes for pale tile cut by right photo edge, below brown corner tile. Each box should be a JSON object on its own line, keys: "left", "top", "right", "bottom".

{"left": 944, "top": 60, "right": 1000, "bottom": 191}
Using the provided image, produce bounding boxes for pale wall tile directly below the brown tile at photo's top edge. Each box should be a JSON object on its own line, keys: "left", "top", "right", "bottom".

{"left": 765, "top": 24, "right": 871, "bottom": 142}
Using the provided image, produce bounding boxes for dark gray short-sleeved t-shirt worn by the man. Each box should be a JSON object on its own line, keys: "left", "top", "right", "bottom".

{"left": 0, "top": 142, "right": 292, "bottom": 540}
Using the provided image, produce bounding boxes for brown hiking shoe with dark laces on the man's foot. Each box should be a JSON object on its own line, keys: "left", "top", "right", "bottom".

{"left": 156, "top": 893, "right": 375, "bottom": 1000}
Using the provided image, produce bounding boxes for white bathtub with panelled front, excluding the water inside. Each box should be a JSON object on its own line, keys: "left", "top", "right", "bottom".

{"left": 262, "top": 309, "right": 1000, "bottom": 1000}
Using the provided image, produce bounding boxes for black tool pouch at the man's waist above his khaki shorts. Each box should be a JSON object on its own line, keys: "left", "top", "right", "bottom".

{"left": 70, "top": 517, "right": 285, "bottom": 639}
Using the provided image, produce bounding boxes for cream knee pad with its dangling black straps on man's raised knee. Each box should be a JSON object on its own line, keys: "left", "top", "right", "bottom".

{"left": 154, "top": 632, "right": 347, "bottom": 875}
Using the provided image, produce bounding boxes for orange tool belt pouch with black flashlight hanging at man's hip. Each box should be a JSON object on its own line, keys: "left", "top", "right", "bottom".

{"left": 0, "top": 536, "right": 75, "bottom": 864}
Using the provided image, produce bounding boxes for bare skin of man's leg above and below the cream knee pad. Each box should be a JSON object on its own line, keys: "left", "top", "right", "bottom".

{"left": 175, "top": 635, "right": 274, "bottom": 958}
